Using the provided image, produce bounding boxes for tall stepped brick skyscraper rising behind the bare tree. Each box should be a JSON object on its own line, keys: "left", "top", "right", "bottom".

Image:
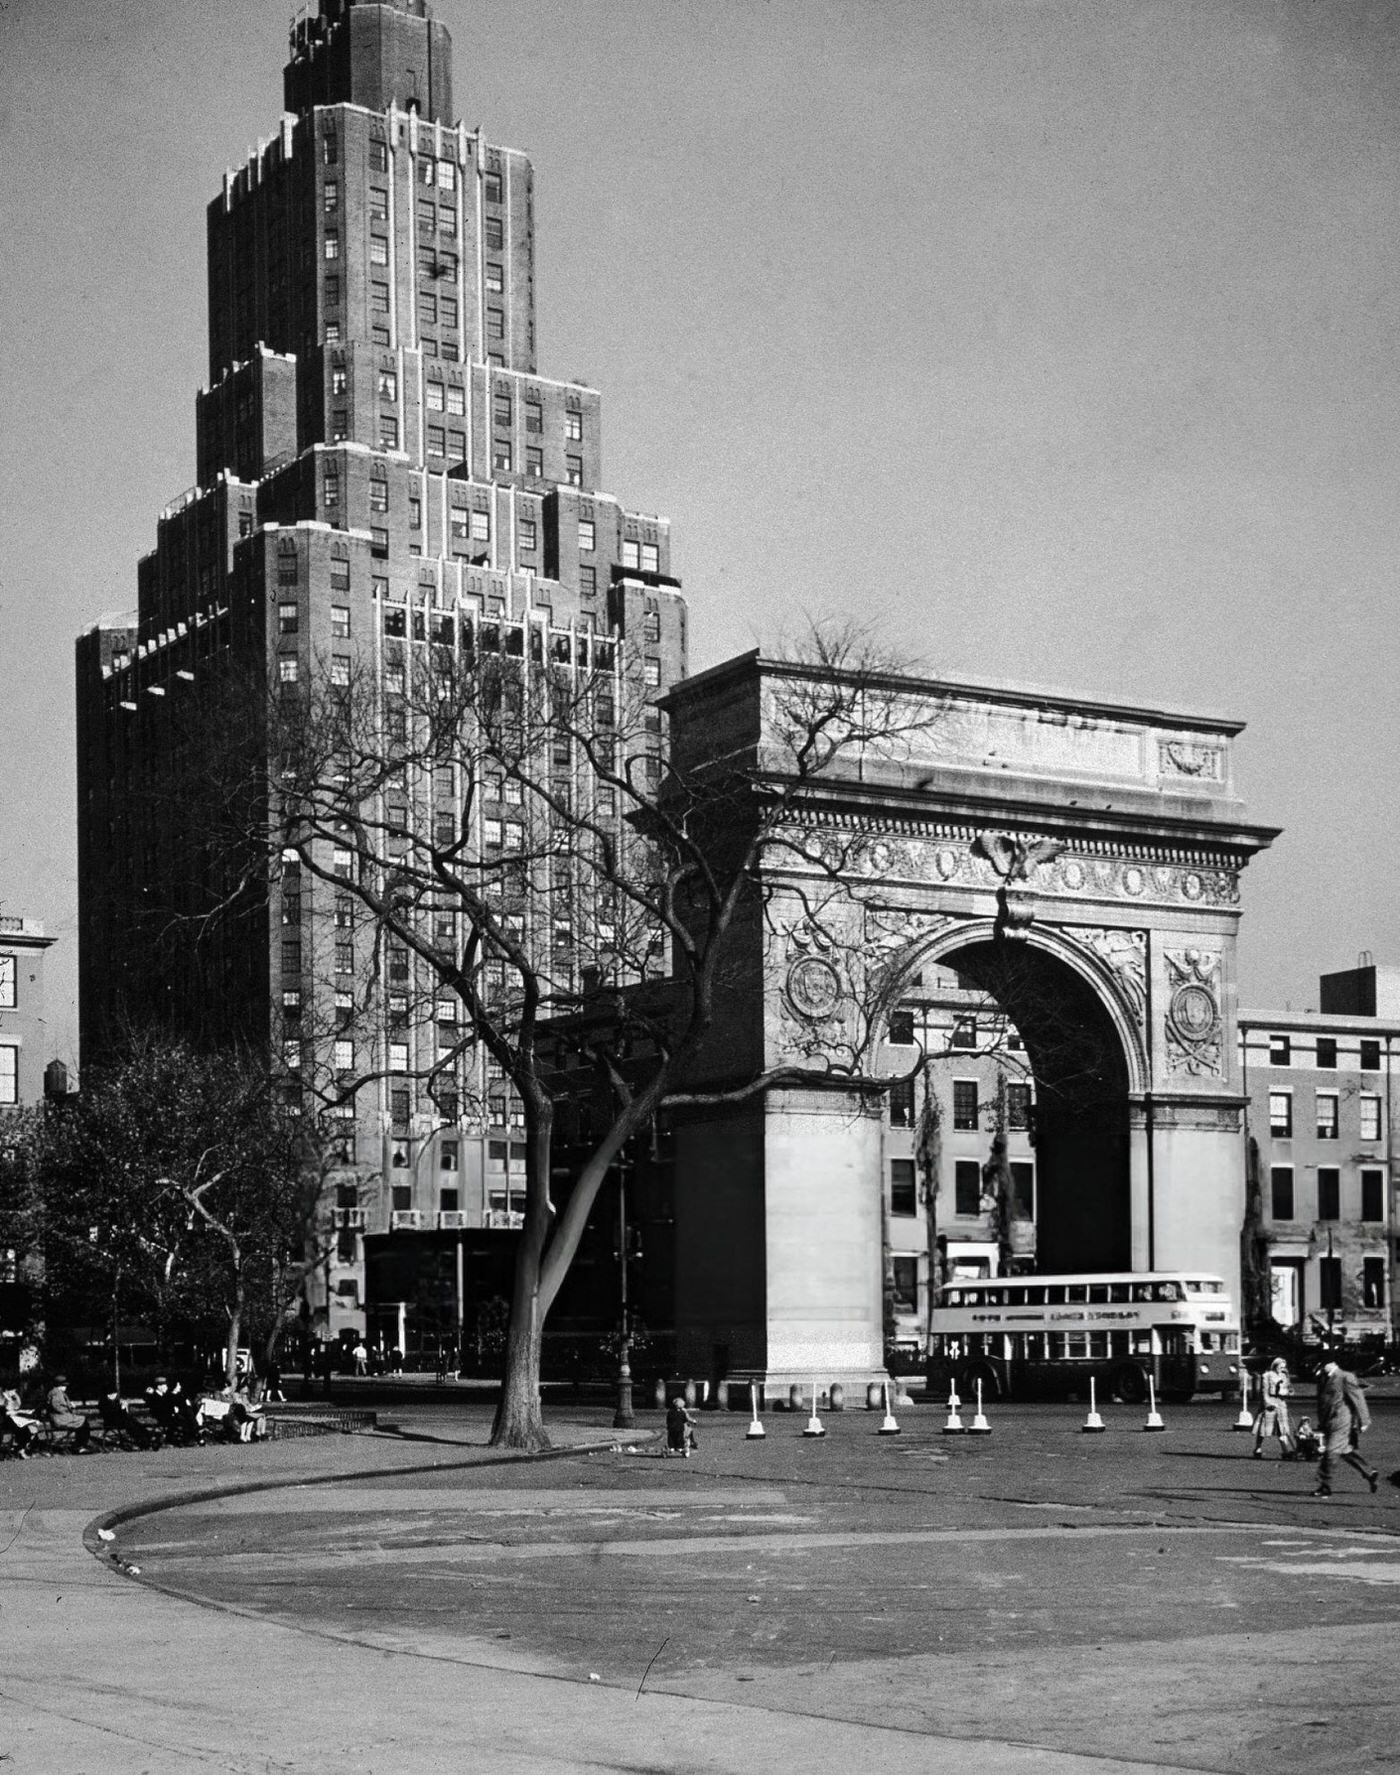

{"left": 78, "top": 0, "right": 685, "bottom": 1335}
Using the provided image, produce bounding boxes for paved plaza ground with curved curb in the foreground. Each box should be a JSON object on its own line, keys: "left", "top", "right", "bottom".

{"left": 0, "top": 1397, "right": 1400, "bottom": 1775}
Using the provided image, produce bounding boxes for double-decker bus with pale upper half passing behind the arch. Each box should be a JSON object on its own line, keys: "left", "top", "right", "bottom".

{"left": 928, "top": 1271, "right": 1240, "bottom": 1404}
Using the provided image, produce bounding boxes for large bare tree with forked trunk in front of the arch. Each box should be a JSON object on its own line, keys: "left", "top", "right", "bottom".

{"left": 177, "top": 616, "right": 939, "bottom": 1448}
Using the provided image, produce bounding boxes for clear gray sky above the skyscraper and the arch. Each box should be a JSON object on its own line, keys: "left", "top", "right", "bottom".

{"left": 0, "top": 0, "right": 1400, "bottom": 1056}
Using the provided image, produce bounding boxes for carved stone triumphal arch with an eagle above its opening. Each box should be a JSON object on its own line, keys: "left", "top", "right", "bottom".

{"left": 667, "top": 655, "right": 1276, "bottom": 1386}
